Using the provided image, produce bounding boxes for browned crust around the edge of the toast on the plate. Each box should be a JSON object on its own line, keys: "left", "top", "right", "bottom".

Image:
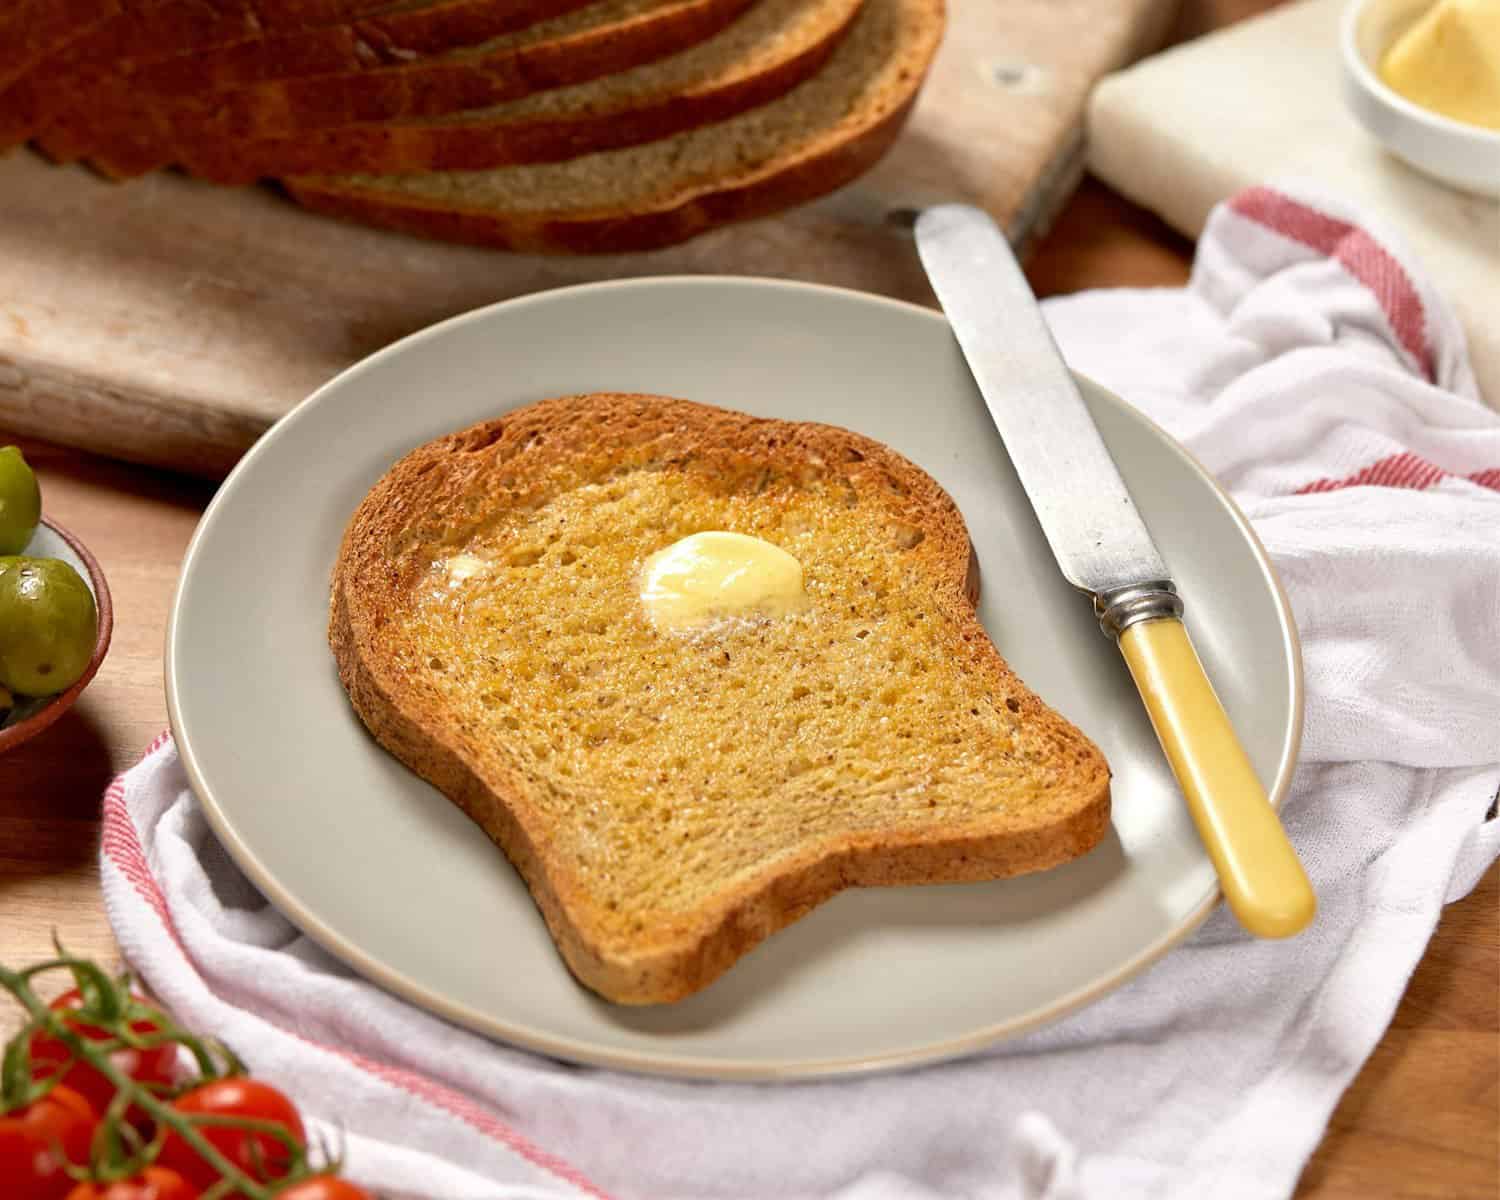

{"left": 329, "top": 393, "right": 1110, "bottom": 1004}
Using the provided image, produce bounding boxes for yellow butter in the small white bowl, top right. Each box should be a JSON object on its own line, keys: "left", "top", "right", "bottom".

{"left": 1380, "top": 0, "right": 1500, "bottom": 129}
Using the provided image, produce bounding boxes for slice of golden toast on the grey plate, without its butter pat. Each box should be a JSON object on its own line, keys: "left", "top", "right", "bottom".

{"left": 329, "top": 393, "right": 1109, "bottom": 1004}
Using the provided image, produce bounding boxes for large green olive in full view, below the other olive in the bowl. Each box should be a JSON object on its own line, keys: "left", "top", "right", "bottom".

{"left": 0, "top": 557, "right": 99, "bottom": 696}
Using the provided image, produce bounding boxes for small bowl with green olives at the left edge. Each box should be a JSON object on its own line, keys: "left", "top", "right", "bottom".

{"left": 0, "top": 446, "right": 114, "bottom": 753}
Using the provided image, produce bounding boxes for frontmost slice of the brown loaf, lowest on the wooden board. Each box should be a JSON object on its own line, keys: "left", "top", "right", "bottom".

{"left": 285, "top": 0, "right": 944, "bottom": 254}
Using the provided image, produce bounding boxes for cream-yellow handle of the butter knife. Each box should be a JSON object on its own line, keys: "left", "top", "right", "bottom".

{"left": 1119, "top": 617, "right": 1317, "bottom": 938}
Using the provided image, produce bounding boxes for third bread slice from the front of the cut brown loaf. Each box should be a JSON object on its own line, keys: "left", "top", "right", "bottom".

{"left": 41, "top": 0, "right": 753, "bottom": 177}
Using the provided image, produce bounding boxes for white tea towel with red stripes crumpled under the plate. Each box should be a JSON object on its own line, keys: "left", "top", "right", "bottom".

{"left": 102, "top": 189, "right": 1500, "bottom": 1200}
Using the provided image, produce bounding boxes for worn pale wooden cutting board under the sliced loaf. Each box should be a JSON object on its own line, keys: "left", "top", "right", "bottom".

{"left": 0, "top": 0, "right": 1176, "bottom": 477}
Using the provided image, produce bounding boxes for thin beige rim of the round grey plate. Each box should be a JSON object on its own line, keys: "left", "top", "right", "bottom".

{"left": 162, "top": 275, "right": 1305, "bottom": 1083}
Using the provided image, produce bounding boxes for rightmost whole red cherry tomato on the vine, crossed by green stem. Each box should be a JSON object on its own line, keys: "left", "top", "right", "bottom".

{"left": 156, "top": 1077, "right": 306, "bottom": 1191}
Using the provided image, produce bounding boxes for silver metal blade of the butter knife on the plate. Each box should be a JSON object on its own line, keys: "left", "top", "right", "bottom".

{"left": 917, "top": 204, "right": 1169, "bottom": 597}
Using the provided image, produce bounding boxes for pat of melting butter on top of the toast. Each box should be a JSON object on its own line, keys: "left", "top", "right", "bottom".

{"left": 641, "top": 531, "right": 807, "bottom": 629}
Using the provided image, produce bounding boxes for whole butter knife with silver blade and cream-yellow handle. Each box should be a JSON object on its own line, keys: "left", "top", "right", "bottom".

{"left": 917, "top": 204, "right": 1317, "bottom": 938}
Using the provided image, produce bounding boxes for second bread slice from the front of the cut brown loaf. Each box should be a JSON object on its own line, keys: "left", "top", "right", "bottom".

{"left": 179, "top": 0, "right": 863, "bottom": 183}
